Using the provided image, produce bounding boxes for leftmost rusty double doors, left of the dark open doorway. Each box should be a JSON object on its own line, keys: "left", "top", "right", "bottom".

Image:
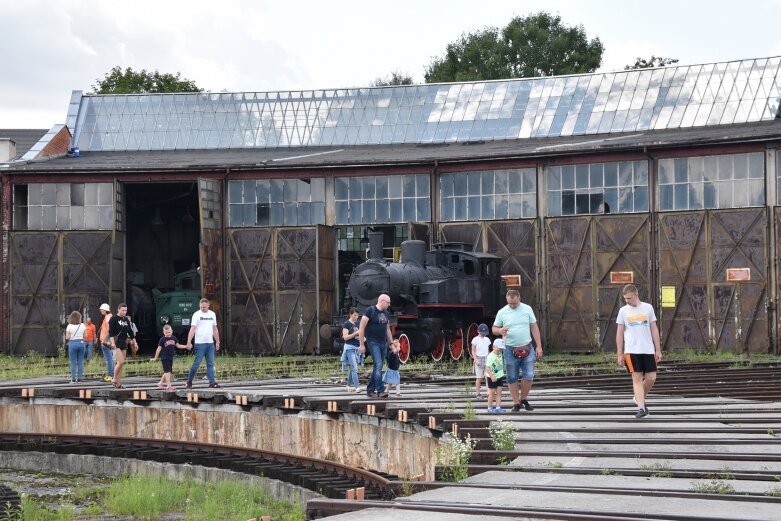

{"left": 10, "top": 232, "right": 111, "bottom": 355}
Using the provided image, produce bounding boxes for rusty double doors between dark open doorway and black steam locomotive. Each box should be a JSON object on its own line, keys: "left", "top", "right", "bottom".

{"left": 228, "top": 227, "right": 335, "bottom": 354}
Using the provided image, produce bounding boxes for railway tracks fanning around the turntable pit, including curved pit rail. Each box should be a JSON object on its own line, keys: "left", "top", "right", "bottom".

{"left": 0, "top": 363, "right": 781, "bottom": 521}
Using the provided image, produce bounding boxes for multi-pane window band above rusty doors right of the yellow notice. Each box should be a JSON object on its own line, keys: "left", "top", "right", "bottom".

{"left": 659, "top": 152, "right": 765, "bottom": 211}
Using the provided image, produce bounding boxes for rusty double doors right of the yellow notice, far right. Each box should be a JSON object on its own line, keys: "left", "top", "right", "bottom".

{"left": 659, "top": 208, "right": 769, "bottom": 352}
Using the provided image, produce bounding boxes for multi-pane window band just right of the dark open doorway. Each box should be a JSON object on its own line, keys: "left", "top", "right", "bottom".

{"left": 228, "top": 178, "right": 325, "bottom": 228}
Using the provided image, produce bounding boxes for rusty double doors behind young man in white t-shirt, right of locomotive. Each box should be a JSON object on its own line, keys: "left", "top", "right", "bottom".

{"left": 545, "top": 214, "right": 653, "bottom": 351}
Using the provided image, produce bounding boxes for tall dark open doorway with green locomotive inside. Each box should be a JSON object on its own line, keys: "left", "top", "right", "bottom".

{"left": 125, "top": 182, "right": 201, "bottom": 347}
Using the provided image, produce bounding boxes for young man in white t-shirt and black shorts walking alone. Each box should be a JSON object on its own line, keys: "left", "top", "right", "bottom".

{"left": 616, "top": 284, "right": 662, "bottom": 418}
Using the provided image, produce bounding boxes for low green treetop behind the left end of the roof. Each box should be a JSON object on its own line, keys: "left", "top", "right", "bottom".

{"left": 92, "top": 66, "right": 203, "bottom": 94}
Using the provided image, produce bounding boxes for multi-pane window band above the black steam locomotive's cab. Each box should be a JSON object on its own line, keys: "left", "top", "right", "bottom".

{"left": 439, "top": 168, "right": 537, "bottom": 221}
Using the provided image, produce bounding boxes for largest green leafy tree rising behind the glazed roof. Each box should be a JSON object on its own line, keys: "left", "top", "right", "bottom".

{"left": 426, "top": 12, "right": 604, "bottom": 83}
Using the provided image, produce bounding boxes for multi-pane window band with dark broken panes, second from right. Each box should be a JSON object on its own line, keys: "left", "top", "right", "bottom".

{"left": 545, "top": 161, "right": 648, "bottom": 216}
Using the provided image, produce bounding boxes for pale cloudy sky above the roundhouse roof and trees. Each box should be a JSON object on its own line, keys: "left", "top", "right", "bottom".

{"left": 0, "top": 0, "right": 781, "bottom": 129}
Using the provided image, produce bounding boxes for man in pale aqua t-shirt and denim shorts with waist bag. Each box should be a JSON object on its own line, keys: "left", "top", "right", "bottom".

{"left": 493, "top": 289, "right": 542, "bottom": 412}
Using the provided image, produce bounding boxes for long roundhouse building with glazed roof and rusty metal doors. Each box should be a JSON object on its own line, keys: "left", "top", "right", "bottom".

{"left": 0, "top": 57, "right": 781, "bottom": 353}
